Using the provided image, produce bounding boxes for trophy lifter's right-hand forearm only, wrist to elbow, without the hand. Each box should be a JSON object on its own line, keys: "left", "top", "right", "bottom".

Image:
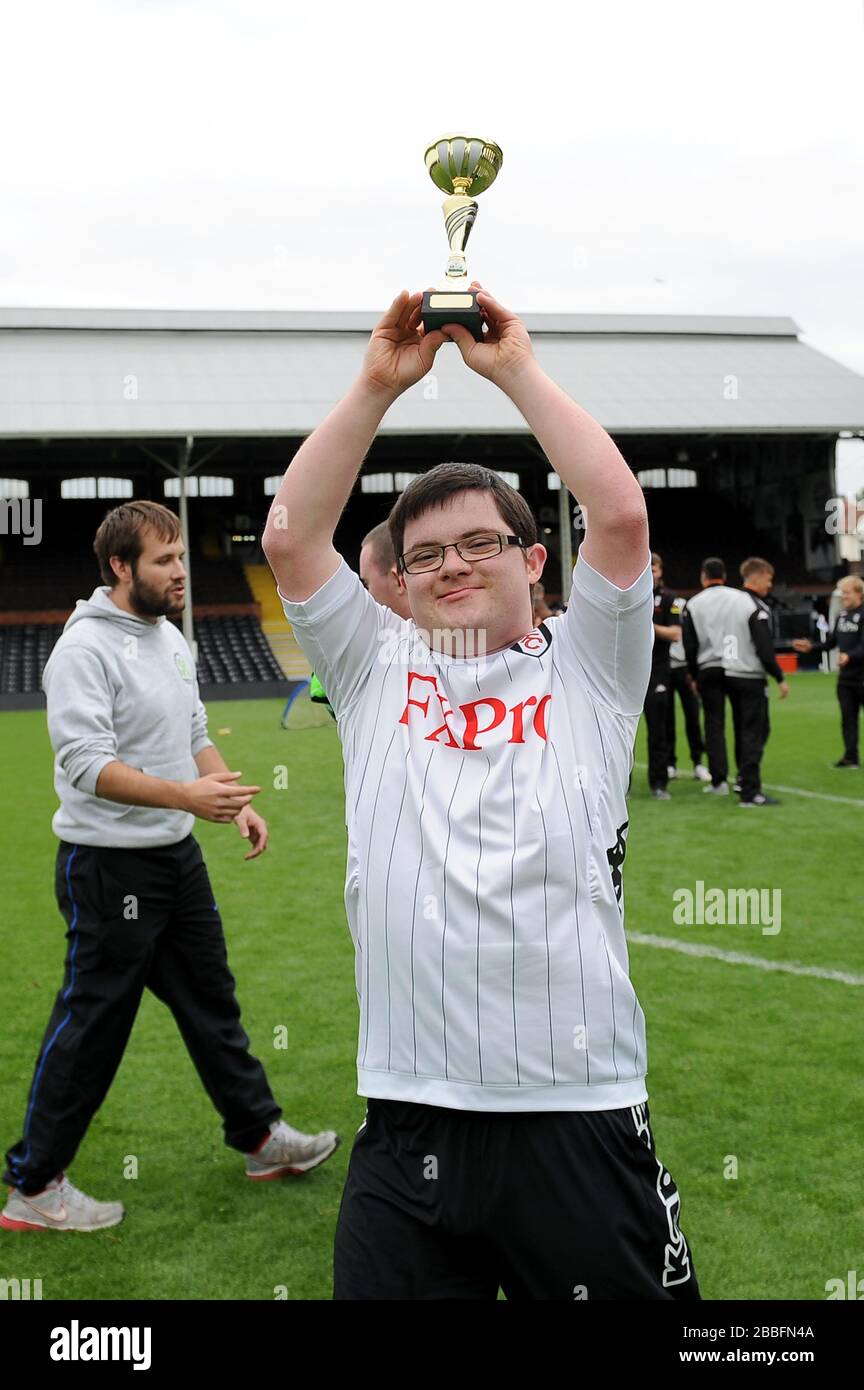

{"left": 507, "top": 363, "right": 645, "bottom": 528}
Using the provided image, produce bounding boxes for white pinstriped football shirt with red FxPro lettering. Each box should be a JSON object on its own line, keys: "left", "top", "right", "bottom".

{"left": 279, "top": 547, "right": 653, "bottom": 1111}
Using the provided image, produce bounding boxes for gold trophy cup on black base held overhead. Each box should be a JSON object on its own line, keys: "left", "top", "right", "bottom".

{"left": 421, "top": 135, "right": 504, "bottom": 342}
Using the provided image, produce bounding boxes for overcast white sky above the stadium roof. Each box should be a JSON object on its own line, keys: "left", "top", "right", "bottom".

{"left": 0, "top": 0, "right": 864, "bottom": 483}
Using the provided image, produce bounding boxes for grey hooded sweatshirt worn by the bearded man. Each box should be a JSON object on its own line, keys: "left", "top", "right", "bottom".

{"left": 42, "top": 587, "right": 211, "bottom": 849}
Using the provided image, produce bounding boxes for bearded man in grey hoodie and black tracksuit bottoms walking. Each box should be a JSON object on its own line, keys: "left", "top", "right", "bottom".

{"left": 0, "top": 502, "right": 339, "bottom": 1230}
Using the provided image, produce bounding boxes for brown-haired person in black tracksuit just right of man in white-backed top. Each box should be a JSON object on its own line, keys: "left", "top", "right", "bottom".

{"left": 724, "top": 556, "right": 789, "bottom": 806}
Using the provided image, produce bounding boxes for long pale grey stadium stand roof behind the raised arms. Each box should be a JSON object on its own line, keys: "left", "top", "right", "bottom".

{"left": 0, "top": 309, "right": 864, "bottom": 438}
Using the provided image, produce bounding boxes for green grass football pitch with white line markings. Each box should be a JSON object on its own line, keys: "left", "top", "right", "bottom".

{"left": 0, "top": 674, "right": 864, "bottom": 1300}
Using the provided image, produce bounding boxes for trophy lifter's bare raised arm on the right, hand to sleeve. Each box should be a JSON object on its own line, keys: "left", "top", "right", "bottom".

{"left": 445, "top": 281, "right": 649, "bottom": 589}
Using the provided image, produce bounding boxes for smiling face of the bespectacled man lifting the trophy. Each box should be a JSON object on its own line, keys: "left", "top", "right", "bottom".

{"left": 400, "top": 489, "right": 546, "bottom": 653}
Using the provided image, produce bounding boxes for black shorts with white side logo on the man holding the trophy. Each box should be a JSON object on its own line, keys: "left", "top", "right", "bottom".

{"left": 333, "top": 1099, "right": 700, "bottom": 1301}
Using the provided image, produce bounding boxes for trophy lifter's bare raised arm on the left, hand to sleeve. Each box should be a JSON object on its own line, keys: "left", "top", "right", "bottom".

{"left": 261, "top": 291, "right": 445, "bottom": 603}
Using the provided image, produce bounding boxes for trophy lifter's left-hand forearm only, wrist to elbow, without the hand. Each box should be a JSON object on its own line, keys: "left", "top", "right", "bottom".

{"left": 263, "top": 381, "right": 397, "bottom": 555}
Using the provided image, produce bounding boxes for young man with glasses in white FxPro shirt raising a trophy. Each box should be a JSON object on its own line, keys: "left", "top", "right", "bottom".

{"left": 264, "top": 282, "right": 699, "bottom": 1300}
